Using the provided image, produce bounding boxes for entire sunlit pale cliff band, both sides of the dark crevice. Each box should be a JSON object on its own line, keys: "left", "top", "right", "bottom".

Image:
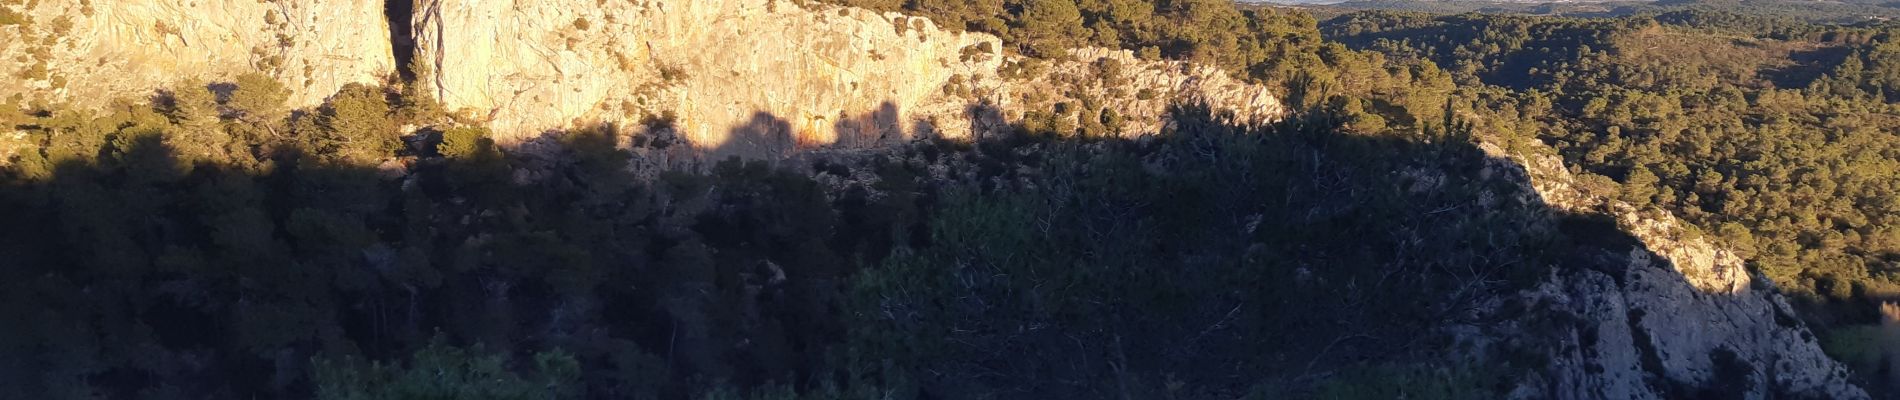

{"left": 0, "top": 0, "right": 1281, "bottom": 157}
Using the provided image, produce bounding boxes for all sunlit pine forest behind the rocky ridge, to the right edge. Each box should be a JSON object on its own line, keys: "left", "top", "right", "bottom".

{"left": 838, "top": 0, "right": 1900, "bottom": 394}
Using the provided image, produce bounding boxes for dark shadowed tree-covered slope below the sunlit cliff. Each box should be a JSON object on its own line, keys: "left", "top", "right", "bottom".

{"left": 0, "top": 95, "right": 1824, "bottom": 398}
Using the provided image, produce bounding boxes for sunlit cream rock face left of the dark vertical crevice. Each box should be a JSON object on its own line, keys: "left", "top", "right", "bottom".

{"left": 0, "top": 0, "right": 395, "bottom": 106}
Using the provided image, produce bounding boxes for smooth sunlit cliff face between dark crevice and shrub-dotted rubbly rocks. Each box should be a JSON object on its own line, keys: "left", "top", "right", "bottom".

{"left": 414, "top": 0, "right": 1001, "bottom": 150}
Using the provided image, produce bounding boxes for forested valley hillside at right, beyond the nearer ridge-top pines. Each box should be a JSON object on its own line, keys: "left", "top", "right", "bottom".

{"left": 1322, "top": 8, "right": 1900, "bottom": 392}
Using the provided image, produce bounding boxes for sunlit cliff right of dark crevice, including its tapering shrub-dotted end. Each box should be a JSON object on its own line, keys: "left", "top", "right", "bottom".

{"left": 414, "top": 0, "right": 1281, "bottom": 148}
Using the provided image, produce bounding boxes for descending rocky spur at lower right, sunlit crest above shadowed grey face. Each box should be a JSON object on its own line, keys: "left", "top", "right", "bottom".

{"left": 1484, "top": 144, "right": 1868, "bottom": 398}
